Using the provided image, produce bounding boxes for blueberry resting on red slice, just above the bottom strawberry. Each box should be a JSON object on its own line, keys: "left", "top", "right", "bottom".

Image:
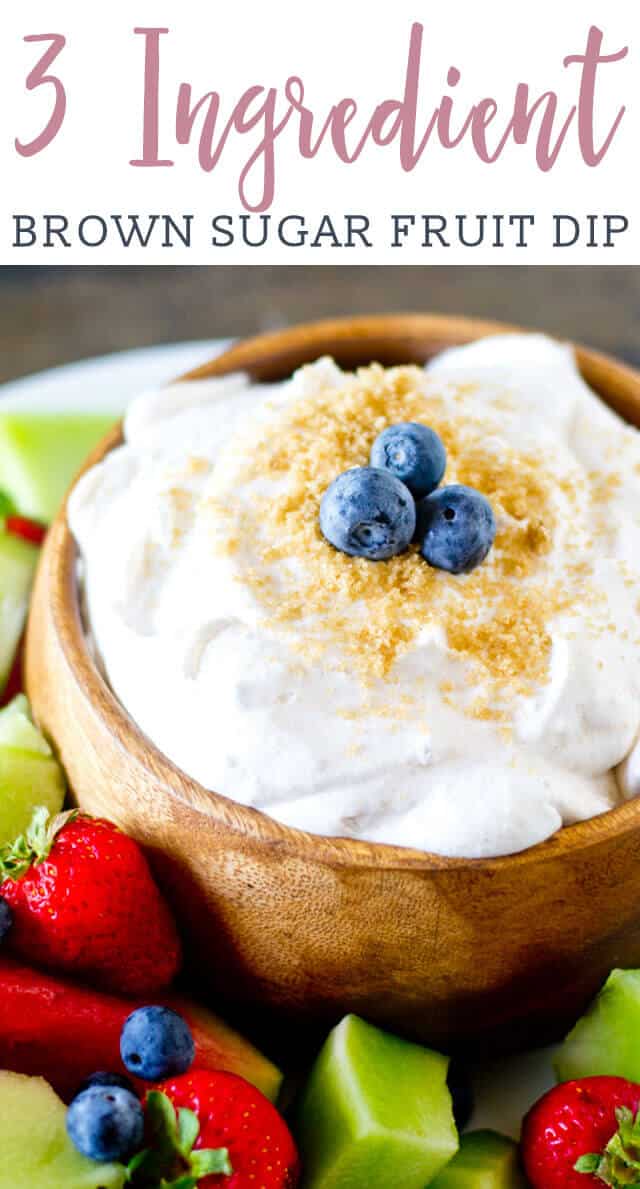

{"left": 120, "top": 1007, "right": 195, "bottom": 1082}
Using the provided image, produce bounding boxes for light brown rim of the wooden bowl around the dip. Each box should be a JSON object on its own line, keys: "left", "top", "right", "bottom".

{"left": 49, "top": 314, "right": 640, "bottom": 875}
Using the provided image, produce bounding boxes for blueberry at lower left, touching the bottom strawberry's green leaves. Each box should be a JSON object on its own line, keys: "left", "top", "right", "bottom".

{"left": 67, "top": 1086, "right": 144, "bottom": 1163}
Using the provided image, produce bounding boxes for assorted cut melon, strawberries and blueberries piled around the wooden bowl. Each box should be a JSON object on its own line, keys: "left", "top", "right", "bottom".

{"left": 0, "top": 347, "right": 640, "bottom": 1189}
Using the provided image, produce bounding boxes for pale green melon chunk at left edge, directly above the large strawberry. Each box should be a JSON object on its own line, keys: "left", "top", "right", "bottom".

{"left": 0, "top": 694, "right": 65, "bottom": 845}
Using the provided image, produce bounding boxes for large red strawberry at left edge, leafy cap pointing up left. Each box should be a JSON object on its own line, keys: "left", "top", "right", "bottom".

{"left": 0, "top": 810, "right": 181, "bottom": 995}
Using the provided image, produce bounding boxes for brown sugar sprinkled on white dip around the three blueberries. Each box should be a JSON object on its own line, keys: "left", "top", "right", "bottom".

{"left": 208, "top": 365, "right": 597, "bottom": 719}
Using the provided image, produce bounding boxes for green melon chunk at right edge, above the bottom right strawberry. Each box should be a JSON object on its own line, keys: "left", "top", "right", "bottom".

{"left": 554, "top": 970, "right": 640, "bottom": 1082}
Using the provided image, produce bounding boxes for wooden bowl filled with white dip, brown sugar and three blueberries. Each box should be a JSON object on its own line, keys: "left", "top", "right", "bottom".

{"left": 26, "top": 316, "right": 640, "bottom": 1046}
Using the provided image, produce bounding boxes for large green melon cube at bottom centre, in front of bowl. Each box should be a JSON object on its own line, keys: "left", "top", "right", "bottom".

{"left": 297, "top": 1015, "right": 458, "bottom": 1189}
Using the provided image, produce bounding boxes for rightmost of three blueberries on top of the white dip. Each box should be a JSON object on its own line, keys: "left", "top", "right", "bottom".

{"left": 418, "top": 484, "right": 496, "bottom": 574}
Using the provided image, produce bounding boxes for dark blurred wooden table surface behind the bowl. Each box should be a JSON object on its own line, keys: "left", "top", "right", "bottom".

{"left": 0, "top": 265, "right": 640, "bottom": 382}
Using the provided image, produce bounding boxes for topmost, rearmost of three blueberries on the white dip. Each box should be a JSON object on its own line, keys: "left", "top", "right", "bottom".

{"left": 370, "top": 421, "right": 446, "bottom": 499}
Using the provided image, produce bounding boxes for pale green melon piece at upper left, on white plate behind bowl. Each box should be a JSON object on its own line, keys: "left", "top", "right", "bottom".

{"left": 0, "top": 411, "right": 115, "bottom": 524}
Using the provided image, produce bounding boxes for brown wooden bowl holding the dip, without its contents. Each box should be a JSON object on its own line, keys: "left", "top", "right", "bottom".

{"left": 26, "top": 315, "right": 640, "bottom": 1048}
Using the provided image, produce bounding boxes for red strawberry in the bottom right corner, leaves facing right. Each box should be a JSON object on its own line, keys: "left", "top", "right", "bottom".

{"left": 521, "top": 1077, "right": 640, "bottom": 1189}
